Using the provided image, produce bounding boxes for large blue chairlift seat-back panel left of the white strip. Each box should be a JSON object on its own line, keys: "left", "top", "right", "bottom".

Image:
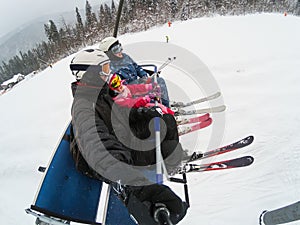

{"left": 32, "top": 126, "right": 102, "bottom": 223}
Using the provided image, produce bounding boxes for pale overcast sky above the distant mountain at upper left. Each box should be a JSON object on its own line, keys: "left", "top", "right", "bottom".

{"left": 0, "top": 0, "right": 103, "bottom": 37}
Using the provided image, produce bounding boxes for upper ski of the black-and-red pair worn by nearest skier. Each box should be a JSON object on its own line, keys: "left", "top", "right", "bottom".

{"left": 187, "top": 135, "right": 254, "bottom": 162}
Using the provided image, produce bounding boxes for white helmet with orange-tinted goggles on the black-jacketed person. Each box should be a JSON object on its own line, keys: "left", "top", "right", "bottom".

{"left": 70, "top": 49, "right": 110, "bottom": 80}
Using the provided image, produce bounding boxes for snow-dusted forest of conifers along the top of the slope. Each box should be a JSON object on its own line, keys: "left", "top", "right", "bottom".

{"left": 0, "top": 0, "right": 300, "bottom": 83}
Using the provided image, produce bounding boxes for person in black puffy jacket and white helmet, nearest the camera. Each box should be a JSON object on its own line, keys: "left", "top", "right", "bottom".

{"left": 70, "top": 49, "right": 187, "bottom": 225}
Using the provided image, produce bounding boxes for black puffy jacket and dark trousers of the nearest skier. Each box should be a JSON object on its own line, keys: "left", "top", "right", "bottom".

{"left": 72, "top": 71, "right": 182, "bottom": 186}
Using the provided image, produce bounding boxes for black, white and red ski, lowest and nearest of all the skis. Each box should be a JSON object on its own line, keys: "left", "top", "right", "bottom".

{"left": 178, "top": 156, "right": 254, "bottom": 173}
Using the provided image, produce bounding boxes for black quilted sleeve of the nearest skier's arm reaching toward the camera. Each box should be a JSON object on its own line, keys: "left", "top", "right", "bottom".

{"left": 72, "top": 99, "right": 149, "bottom": 185}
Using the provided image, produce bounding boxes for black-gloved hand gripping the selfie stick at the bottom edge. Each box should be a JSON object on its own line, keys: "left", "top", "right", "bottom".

{"left": 129, "top": 184, "right": 188, "bottom": 224}
